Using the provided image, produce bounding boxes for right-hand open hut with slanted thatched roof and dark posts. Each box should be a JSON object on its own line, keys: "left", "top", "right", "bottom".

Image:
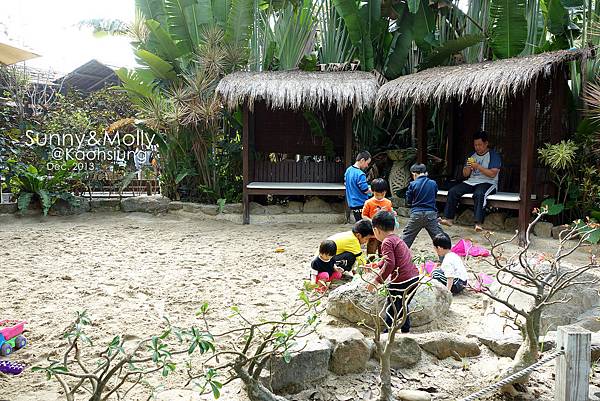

{"left": 376, "top": 49, "right": 592, "bottom": 243}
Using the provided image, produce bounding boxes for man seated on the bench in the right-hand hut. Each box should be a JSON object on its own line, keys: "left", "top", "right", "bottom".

{"left": 440, "top": 131, "right": 502, "bottom": 231}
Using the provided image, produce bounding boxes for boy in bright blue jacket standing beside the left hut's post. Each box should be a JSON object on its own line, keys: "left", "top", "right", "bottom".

{"left": 344, "top": 150, "right": 371, "bottom": 221}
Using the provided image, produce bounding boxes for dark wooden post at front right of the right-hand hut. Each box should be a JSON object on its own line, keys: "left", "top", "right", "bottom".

{"left": 516, "top": 81, "right": 537, "bottom": 246}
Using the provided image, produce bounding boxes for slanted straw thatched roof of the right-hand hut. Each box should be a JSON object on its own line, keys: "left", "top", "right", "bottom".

{"left": 376, "top": 50, "right": 589, "bottom": 113}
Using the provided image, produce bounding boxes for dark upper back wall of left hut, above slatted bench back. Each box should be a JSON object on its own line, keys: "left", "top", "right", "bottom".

{"left": 254, "top": 102, "right": 344, "bottom": 157}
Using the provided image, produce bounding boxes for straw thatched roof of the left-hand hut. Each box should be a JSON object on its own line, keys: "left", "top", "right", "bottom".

{"left": 217, "top": 70, "right": 379, "bottom": 113}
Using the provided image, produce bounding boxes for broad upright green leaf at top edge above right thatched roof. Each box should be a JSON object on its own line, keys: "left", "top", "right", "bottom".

{"left": 490, "top": 0, "right": 527, "bottom": 58}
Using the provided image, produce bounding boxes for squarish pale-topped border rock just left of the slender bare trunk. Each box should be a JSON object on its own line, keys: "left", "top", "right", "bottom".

{"left": 319, "top": 327, "right": 373, "bottom": 375}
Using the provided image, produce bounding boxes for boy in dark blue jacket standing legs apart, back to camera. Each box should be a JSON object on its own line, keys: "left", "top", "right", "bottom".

{"left": 402, "top": 164, "right": 444, "bottom": 248}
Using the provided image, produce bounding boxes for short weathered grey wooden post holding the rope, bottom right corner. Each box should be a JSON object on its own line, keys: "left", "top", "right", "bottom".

{"left": 554, "top": 326, "right": 592, "bottom": 401}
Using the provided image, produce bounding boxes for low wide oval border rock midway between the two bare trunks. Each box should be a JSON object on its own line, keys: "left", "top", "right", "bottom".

{"left": 416, "top": 331, "right": 481, "bottom": 359}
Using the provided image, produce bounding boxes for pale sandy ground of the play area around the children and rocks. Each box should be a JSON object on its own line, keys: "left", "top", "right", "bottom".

{"left": 0, "top": 212, "right": 597, "bottom": 401}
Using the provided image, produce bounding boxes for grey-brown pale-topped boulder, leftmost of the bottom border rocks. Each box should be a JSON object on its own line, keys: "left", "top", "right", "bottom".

{"left": 261, "top": 336, "right": 332, "bottom": 393}
